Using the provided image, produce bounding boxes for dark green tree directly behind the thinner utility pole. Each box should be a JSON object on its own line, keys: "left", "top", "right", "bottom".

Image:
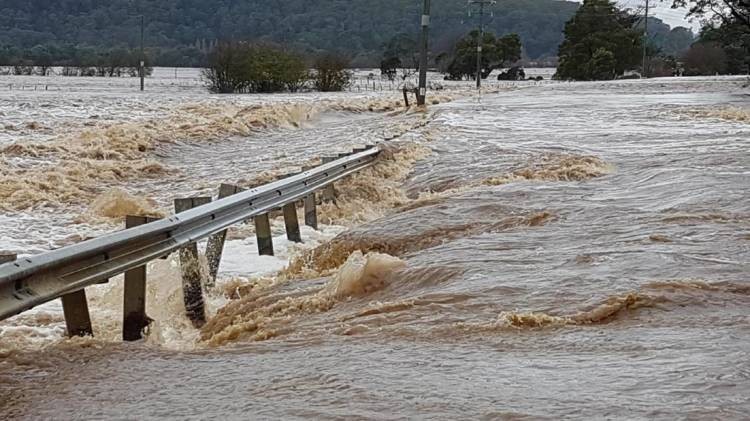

{"left": 447, "top": 30, "right": 521, "bottom": 80}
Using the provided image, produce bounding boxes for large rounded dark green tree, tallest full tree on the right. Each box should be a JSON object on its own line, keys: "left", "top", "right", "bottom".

{"left": 555, "top": 0, "right": 642, "bottom": 80}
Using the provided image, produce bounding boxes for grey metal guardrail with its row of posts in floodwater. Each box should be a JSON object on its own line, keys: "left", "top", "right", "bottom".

{"left": 0, "top": 149, "right": 380, "bottom": 338}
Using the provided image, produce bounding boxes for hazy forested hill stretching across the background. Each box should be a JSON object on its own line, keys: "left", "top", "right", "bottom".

{"left": 0, "top": 0, "right": 579, "bottom": 64}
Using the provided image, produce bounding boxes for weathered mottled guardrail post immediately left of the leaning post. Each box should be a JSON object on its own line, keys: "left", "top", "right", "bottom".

{"left": 174, "top": 197, "right": 211, "bottom": 327}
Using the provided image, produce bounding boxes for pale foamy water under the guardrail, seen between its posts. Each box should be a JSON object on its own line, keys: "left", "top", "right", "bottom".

{"left": 0, "top": 218, "right": 345, "bottom": 351}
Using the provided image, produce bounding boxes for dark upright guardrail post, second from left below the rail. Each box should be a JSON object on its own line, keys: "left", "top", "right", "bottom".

{"left": 122, "top": 215, "right": 156, "bottom": 341}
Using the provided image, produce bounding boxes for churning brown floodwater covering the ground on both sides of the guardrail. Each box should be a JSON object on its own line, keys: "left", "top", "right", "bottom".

{"left": 0, "top": 71, "right": 750, "bottom": 419}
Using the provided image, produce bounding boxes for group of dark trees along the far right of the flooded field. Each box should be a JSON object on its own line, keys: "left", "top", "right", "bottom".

{"left": 556, "top": 0, "right": 750, "bottom": 80}
